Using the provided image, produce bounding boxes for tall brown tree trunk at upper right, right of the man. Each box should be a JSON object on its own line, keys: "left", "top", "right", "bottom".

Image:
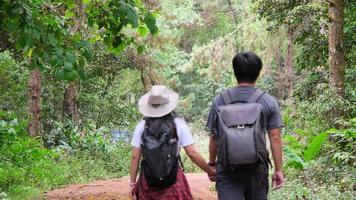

{"left": 329, "top": 0, "right": 345, "bottom": 95}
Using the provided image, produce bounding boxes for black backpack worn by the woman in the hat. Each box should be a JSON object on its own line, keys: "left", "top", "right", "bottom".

{"left": 141, "top": 116, "right": 179, "bottom": 189}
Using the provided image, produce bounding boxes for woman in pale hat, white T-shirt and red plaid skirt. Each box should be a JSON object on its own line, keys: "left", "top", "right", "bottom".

{"left": 129, "top": 85, "right": 215, "bottom": 200}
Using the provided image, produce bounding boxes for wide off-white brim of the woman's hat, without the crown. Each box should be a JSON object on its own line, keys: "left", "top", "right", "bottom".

{"left": 138, "top": 91, "right": 179, "bottom": 117}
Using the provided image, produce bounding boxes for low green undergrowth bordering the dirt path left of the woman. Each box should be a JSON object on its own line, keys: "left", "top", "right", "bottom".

{"left": 0, "top": 113, "right": 130, "bottom": 199}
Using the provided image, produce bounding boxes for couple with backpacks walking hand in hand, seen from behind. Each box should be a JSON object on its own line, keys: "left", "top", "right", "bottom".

{"left": 130, "top": 52, "right": 284, "bottom": 200}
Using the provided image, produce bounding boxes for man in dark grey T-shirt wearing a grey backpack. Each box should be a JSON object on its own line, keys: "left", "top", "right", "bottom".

{"left": 206, "top": 52, "right": 284, "bottom": 200}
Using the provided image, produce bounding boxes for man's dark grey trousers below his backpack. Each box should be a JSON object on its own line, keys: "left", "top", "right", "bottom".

{"left": 216, "top": 165, "right": 268, "bottom": 200}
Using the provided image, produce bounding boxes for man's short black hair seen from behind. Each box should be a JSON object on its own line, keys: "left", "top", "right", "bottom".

{"left": 232, "top": 51, "right": 262, "bottom": 83}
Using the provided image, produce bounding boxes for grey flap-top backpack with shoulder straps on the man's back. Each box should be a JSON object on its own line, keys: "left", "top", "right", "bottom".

{"left": 217, "top": 89, "right": 268, "bottom": 171}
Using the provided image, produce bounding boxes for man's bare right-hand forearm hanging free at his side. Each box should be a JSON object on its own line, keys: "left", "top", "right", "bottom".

{"left": 268, "top": 128, "right": 284, "bottom": 189}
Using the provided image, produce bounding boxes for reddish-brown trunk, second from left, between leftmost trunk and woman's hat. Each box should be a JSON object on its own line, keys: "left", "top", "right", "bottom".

{"left": 63, "top": 81, "right": 79, "bottom": 125}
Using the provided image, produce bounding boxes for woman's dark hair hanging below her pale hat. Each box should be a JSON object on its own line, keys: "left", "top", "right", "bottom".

{"left": 145, "top": 112, "right": 178, "bottom": 138}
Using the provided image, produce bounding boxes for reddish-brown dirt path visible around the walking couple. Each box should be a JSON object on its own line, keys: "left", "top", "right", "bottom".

{"left": 46, "top": 173, "right": 217, "bottom": 200}
